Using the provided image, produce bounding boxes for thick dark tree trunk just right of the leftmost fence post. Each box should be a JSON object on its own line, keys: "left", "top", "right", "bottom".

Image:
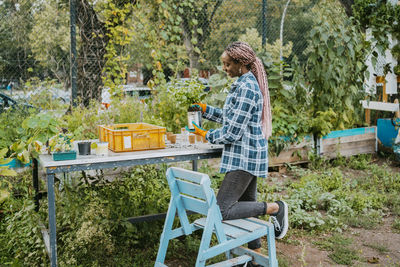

{"left": 77, "top": 0, "right": 108, "bottom": 107}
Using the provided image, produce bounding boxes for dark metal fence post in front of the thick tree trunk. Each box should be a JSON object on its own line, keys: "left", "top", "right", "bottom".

{"left": 69, "top": 0, "right": 77, "bottom": 107}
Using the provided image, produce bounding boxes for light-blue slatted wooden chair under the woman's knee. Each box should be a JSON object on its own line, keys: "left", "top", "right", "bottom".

{"left": 154, "top": 167, "right": 278, "bottom": 267}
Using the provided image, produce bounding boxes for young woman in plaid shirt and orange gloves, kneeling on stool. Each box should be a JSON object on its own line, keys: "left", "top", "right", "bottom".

{"left": 188, "top": 42, "right": 289, "bottom": 252}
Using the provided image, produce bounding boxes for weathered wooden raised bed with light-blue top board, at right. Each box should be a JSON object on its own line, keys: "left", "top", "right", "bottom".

{"left": 317, "top": 126, "right": 378, "bottom": 158}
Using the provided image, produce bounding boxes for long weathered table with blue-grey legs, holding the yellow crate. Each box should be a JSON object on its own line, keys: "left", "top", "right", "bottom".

{"left": 33, "top": 144, "right": 222, "bottom": 267}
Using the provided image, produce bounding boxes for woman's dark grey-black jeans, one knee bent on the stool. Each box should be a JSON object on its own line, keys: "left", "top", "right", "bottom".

{"left": 217, "top": 170, "right": 267, "bottom": 249}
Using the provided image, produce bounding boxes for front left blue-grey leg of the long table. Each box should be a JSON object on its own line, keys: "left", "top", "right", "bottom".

{"left": 47, "top": 174, "right": 57, "bottom": 267}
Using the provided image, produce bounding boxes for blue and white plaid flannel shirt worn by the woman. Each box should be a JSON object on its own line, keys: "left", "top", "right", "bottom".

{"left": 203, "top": 71, "right": 268, "bottom": 177}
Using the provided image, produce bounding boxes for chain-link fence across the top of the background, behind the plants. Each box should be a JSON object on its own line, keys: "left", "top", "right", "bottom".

{"left": 0, "top": 0, "right": 341, "bottom": 98}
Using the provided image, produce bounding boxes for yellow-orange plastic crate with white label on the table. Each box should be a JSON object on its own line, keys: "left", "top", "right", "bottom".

{"left": 99, "top": 123, "right": 166, "bottom": 152}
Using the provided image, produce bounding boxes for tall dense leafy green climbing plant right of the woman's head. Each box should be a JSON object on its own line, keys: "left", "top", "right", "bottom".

{"left": 296, "top": 14, "right": 369, "bottom": 136}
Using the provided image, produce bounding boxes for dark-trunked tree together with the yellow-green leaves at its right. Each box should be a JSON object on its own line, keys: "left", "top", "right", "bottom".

{"left": 77, "top": 0, "right": 136, "bottom": 106}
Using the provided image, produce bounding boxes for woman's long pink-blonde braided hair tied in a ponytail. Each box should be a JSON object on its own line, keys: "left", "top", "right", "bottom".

{"left": 225, "top": 42, "right": 272, "bottom": 139}
